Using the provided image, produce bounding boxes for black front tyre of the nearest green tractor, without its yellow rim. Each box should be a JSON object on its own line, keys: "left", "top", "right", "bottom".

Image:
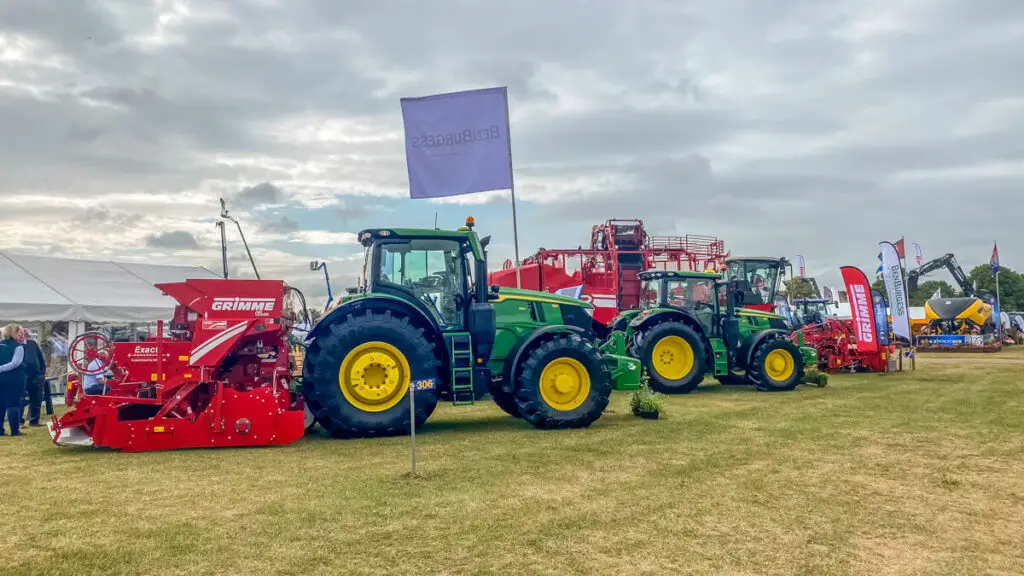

{"left": 515, "top": 334, "right": 611, "bottom": 429}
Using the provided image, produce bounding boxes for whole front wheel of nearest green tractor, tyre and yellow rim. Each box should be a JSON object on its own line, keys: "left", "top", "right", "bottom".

{"left": 515, "top": 334, "right": 611, "bottom": 429}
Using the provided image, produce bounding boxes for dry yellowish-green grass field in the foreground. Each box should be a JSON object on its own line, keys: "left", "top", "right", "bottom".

{"left": 0, "top": 351, "right": 1024, "bottom": 576}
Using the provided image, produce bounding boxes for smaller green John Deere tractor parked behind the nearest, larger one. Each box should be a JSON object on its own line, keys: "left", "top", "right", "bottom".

{"left": 602, "top": 272, "right": 817, "bottom": 394}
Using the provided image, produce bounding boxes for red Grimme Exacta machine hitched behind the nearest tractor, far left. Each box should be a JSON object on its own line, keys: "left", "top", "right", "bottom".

{"left": 49, "top": 280, "right": 305, "bottom": 452}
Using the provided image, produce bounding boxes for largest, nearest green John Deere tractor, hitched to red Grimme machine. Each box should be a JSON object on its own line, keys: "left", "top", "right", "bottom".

{"left": 302, "top": 218, "right": 640, "bottom": 437}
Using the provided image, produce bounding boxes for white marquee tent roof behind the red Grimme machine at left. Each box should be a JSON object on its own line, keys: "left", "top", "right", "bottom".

{"left": 0, "top": 251, "right": 218, "bottom": 322}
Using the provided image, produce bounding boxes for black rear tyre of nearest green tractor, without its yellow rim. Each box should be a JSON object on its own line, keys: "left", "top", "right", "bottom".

{"left": 302, "top": 311, "right": 441, "bottom": 438}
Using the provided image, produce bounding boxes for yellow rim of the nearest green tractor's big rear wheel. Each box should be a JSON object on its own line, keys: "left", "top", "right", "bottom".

{"left": 338, "top": 342, "right": 410, "bottom": 412}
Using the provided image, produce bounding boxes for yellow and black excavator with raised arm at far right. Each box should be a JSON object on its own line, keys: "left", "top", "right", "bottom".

{"left": 907, "top": 254, "right": 994, "bottom": 334}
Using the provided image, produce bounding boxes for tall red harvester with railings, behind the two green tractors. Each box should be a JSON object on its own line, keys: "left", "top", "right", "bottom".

{"left": 487, "top": 219, "right": 727, "bottom": 324}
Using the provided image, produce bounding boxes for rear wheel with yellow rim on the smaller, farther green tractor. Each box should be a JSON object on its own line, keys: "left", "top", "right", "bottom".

{"left": 633, "top": 322, "right": 707, "bottom": 394}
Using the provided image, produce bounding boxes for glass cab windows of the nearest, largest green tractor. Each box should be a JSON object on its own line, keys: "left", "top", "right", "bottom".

{"left": 374, "top": 239, "right": 466, "bottom": 325}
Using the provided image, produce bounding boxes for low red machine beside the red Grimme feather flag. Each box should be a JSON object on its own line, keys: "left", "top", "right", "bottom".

{"left": 793, "top": 298, "right": 895, "bottom": 373}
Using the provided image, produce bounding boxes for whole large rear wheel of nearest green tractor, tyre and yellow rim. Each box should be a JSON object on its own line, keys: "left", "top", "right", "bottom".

{"left": 302, "top": 311, "right": 440, "bottom": 437}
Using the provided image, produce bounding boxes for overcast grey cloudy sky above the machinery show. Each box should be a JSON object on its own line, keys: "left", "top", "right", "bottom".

{"left": 0, "top": 0, "right": 1024, "bottom": 305}
